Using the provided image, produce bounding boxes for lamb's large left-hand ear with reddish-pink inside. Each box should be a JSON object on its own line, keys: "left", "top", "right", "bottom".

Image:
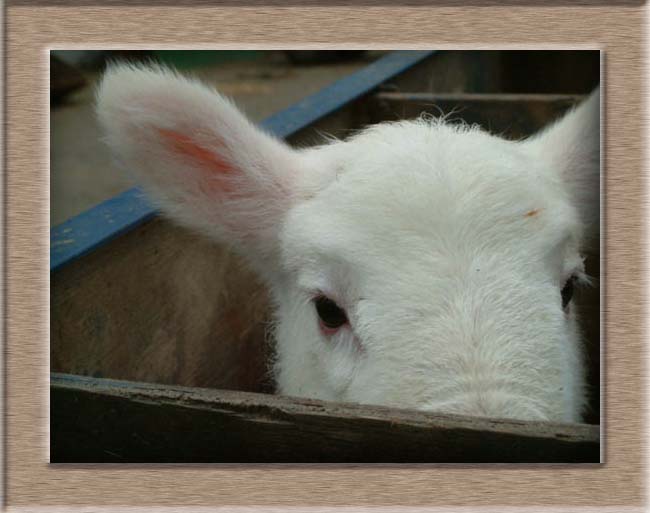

{"left": 97, "top": 65, "right": 301, "bottom": 270}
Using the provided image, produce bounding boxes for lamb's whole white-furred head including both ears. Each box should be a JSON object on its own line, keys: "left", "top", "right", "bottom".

{"left": 98, "top": 66, "right": 599, "bottom": 421}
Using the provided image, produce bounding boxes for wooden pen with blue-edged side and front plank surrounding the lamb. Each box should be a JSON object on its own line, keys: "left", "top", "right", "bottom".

{"left": 50, "top": 51, "right": 600, "bottom": 463}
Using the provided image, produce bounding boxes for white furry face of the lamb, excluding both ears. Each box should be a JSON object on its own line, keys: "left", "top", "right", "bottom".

{"left": 276, "top": 122, "right": 584, "bottom": 420}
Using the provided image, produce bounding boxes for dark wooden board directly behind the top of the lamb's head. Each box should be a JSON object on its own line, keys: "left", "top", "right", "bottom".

{"left": 368, "top": 92, "right": 584, "bottom": 139}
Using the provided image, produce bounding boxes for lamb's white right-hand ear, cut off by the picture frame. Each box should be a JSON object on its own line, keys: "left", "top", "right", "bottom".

{"left": 527, "top": 87, "right": 600, "bottom": 238}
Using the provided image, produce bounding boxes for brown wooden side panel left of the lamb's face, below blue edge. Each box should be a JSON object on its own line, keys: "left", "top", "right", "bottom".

{"left": 50, "top": 219, "right": 270, "bottom": 391}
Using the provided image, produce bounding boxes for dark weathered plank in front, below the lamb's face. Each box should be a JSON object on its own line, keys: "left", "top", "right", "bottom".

{"left": 50, "top": 374, "right": 600, "bottom": 463}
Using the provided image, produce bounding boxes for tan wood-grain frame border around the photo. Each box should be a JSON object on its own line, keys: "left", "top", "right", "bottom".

{"left": 5, "top": 1, "right": 648, "bottom": 511}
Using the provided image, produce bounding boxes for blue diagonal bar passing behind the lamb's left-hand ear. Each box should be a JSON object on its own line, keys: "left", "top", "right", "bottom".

{"left": 50, "top": 51, "right": 435, "bottom": 272}
